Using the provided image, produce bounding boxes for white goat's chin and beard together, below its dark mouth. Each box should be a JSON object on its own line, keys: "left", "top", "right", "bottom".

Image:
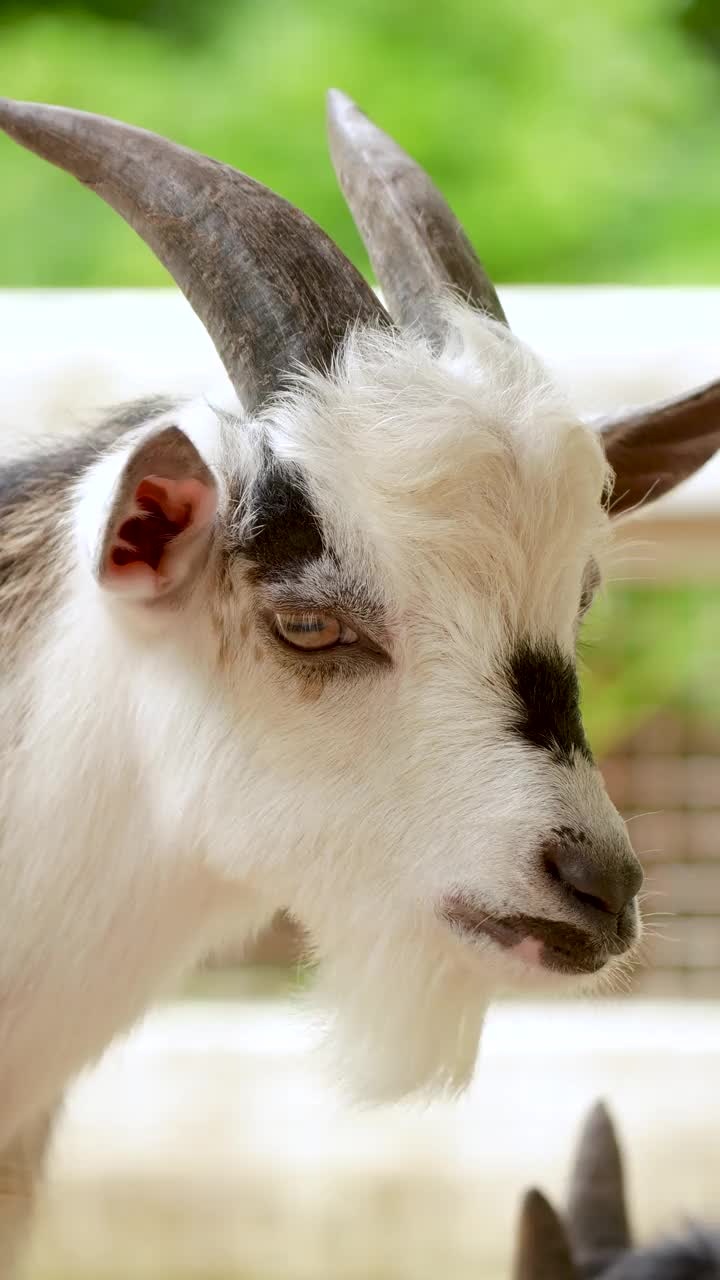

{"left": 304, "top": 928, "right": 618, "bottom": 1105}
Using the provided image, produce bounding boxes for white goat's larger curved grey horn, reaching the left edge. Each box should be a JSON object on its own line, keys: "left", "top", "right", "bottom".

{"left": 0, "top": 99, "right": 388, "bottom": 408}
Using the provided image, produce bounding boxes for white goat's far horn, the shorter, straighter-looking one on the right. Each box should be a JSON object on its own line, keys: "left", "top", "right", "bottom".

{"left": 328, "top": 90, "right": 507, "bottom": 343}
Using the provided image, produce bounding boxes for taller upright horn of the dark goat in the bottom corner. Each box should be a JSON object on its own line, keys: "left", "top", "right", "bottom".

{"left": 568, "top": 1102, "right": 632, "bottom": 1266}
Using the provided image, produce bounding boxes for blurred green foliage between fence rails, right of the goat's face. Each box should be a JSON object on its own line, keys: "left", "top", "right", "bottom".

{"left": 580, "top": 582, "right": 720, "bottom": 756}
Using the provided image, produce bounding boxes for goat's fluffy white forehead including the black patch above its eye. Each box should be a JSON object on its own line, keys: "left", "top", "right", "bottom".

{"left": 222, "top": 314, "right": 607, "bottom": 634}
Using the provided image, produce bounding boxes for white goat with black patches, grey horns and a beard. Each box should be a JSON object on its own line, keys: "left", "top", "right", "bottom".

{"left": 0, "top": 92, "right": 720, "bottom": 1274}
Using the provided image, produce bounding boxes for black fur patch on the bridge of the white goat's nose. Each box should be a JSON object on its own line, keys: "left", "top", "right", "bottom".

{"left": 506, "top": 641, "right": 592, "bottom": 764}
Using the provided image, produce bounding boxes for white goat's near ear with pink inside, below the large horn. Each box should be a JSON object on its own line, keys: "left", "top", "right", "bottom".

{"left": 96, "top": 426, "right": 218, "bottom": 603}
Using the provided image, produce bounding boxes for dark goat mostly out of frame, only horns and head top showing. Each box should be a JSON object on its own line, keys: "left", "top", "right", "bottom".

{"left": 514, "top": 1102, "right": 720, "bottom": 1280}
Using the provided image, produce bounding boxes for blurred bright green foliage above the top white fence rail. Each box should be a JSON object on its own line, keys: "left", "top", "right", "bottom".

{"left": 0, "top": 0, "right": 720, "bottom": 285}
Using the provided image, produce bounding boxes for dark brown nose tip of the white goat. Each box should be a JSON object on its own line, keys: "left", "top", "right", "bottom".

{"left": 543, "top": 842, "right": 643, "bottom": 915}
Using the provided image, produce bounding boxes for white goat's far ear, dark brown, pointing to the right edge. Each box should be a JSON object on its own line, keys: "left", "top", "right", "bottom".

{"left": 601, "top": 383, "right": 720, "bottom": 516}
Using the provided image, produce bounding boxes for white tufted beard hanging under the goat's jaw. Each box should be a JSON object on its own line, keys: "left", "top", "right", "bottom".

{"left": 304, "top": 924, "right": 489, "bottom": 1103}
